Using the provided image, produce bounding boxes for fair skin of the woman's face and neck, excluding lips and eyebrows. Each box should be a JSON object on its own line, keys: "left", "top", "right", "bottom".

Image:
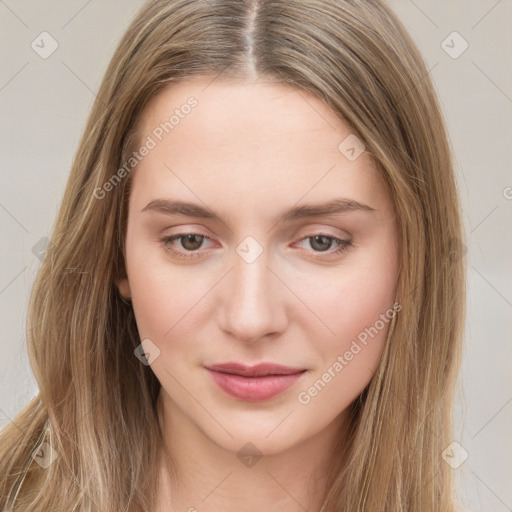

{"left": 117, "top": 79, "right": 399, "bottom": 512}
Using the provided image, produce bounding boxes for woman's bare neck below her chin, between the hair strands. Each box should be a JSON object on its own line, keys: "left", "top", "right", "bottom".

{"left": 152, "top": 390, "right": 349, "bottom": 512}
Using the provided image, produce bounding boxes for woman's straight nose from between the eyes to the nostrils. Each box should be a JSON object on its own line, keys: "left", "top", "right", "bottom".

{"left": 219, "top": 248, "right": 287, "bottom": 343}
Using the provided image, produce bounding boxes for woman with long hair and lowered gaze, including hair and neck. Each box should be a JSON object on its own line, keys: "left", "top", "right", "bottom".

{"left": 0, "top": 0, "right": 464, "bottom": 512}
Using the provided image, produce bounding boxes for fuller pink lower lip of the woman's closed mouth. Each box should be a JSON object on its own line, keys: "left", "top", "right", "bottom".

{"left": 208, "top": 370, "right": 306, "bottom": 402}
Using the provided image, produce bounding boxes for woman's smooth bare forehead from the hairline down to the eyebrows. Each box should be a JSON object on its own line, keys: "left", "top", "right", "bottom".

{"left": 130, "top": 79, "right": 389, "bottom": 217}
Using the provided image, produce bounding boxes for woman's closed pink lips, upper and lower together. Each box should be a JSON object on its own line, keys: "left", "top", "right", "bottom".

{"left": 206, "top": 363, "right": 306, "bottom": 402}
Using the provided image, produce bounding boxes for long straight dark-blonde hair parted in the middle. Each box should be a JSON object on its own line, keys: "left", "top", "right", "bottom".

{"left": 0, "top": 0, "right": 465, "bottom": 512}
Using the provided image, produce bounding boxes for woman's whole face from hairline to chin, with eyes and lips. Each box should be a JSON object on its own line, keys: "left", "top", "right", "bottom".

{"left": 118, "top": 80, "right": 399, "bottom": 453}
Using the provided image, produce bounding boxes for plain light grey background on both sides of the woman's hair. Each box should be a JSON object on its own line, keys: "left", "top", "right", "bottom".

{"left": 0, "top": 0, "right": 512, "bottom": 512}
